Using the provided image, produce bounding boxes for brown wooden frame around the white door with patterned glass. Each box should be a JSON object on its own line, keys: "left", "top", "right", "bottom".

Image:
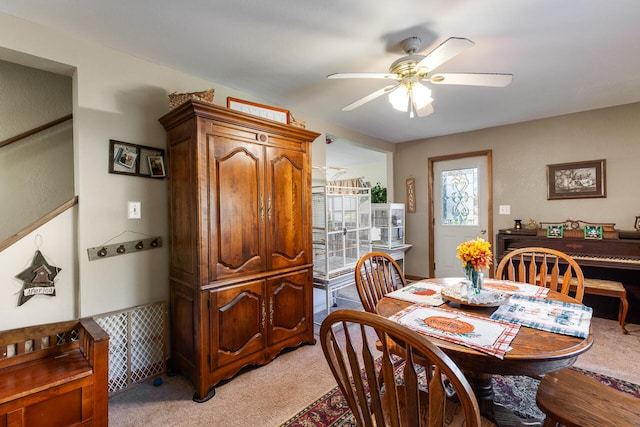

{"left": 427, "top": 150, "right": 494, "bottom": 277}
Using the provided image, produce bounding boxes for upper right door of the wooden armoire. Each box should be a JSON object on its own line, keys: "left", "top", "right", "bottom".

{"left": 267, "top": 147, "right": 311, "bottom": 270}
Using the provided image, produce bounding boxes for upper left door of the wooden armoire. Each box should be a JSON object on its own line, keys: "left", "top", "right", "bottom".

{"left": 209, "top": 135, "right": 266, "bottom": 280}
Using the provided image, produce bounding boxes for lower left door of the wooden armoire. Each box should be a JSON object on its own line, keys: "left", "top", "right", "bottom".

{"left": 210, "top": 281, "right": 266, "bottom": 368}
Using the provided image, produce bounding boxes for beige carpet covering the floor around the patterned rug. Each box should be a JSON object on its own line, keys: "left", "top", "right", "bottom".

{"left": 109, "top": 286, "right": 640, "bottom": 427}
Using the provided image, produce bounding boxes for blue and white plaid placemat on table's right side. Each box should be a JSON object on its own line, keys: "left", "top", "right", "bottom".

{"left": 491, "top": 295, "right": 593, "bottom": 338}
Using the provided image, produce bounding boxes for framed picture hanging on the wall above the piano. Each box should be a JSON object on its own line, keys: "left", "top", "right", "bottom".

{"left": 547, "top": 159, "right": 607, "bottom": 200}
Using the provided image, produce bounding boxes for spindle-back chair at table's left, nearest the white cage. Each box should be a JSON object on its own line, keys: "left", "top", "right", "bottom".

{"left": 355, "top": 252, "right": 407, "bottom": 313}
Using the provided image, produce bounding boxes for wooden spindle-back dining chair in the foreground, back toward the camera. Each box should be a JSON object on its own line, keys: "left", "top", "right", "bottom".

{"left": 320, "top": 310, "right": 494, "bottom": 427}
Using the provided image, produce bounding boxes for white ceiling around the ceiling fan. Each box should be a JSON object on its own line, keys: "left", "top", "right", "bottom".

{"left": 5, "top": 0, "right": 640, "bottom": 142}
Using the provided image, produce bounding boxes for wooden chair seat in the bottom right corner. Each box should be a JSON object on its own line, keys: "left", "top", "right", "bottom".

{"left": 536, "top": 368, "right": 640, "bottom": 427}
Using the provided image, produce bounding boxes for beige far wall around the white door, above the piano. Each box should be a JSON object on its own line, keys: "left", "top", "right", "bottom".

{"left": 395, "top": 103, "right": 640, "bottom": 276}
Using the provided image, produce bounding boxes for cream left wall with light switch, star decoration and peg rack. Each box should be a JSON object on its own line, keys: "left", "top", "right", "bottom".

{"left": 0, "top": 14, "right": 385, "bottom": 329}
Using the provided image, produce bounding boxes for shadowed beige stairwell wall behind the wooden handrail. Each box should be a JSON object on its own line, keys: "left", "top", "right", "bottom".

{"left": 0, "top": 61, "right": 74, "bottom": 241}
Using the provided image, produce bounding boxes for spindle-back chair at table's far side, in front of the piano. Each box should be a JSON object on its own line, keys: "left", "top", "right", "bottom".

{"left": 495, "top": 247, "right": 584, "bottom": 302}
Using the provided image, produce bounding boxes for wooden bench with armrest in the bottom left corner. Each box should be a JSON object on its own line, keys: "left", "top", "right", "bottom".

{"left": 0, "top": 319, "right": 109, "bottom": 427}
